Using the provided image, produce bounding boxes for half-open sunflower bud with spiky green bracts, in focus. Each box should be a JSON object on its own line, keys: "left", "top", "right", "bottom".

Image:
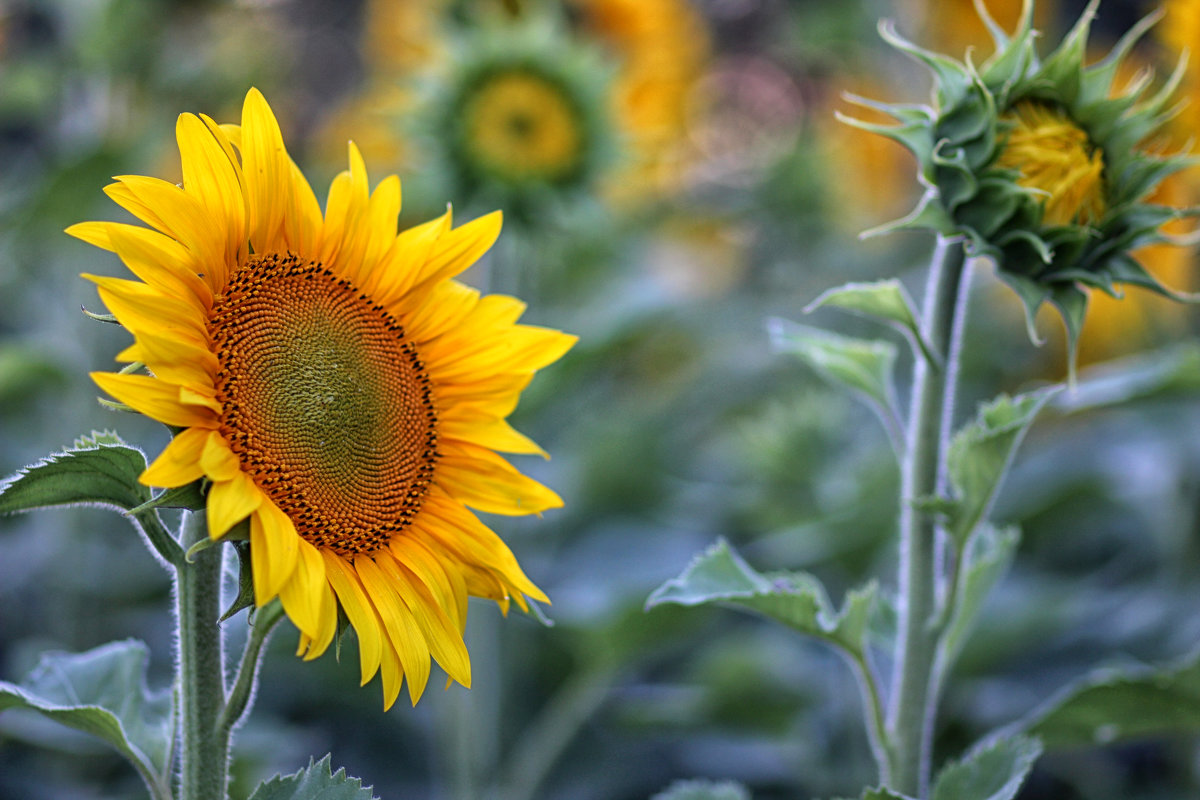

{"left": 844, "top": 0, "right": 1195, "bottom": 354}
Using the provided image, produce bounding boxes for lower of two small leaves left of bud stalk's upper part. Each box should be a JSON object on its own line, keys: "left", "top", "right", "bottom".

{"left": 767, "top": 318, "right": 902, "bottom": 447}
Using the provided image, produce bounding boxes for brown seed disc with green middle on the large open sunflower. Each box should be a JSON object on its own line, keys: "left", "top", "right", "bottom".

{"left": 209, "top": 253, "right": 437, "bottom": 555}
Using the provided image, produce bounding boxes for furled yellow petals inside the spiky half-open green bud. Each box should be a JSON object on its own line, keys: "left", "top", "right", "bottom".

{"left": 996, "top": 101, "right": 1105, "bottom": 225}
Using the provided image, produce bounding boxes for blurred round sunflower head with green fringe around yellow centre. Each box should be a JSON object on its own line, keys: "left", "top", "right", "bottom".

{"left": 425, "top": 19, "right": 614, "bottom": 222}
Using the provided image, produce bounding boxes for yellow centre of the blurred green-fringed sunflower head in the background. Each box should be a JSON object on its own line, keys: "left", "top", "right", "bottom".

{"left": 463, "top": 70, "right": 583, "bottom": 181}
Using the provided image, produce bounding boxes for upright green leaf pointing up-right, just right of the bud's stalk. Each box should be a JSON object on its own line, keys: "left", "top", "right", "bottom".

{"left": 947, "top": 387, "right": 1058, "bottom": 547}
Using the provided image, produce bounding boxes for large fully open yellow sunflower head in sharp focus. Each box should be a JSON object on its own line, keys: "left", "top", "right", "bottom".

{"left": 67, "top": 89, "right": 575, "bottom": 708}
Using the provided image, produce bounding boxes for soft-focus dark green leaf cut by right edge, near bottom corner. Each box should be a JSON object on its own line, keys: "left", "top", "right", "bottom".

{"left": 1020, "top": 651, "right": 1200, "bottom": 750}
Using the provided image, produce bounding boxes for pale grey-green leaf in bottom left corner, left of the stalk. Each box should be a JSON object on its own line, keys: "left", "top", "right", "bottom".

{"left": 0, "top": 639, "right": 175, "bottom": 796}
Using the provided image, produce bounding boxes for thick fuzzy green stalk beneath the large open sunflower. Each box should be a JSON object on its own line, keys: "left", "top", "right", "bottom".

{"left": 175, "top": 511, "right": 229, "bottom": 800}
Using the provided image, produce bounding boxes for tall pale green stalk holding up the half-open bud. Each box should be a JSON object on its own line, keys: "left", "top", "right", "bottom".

{"left": 888, "top": 237, "right": 966, "bottom": 798}
